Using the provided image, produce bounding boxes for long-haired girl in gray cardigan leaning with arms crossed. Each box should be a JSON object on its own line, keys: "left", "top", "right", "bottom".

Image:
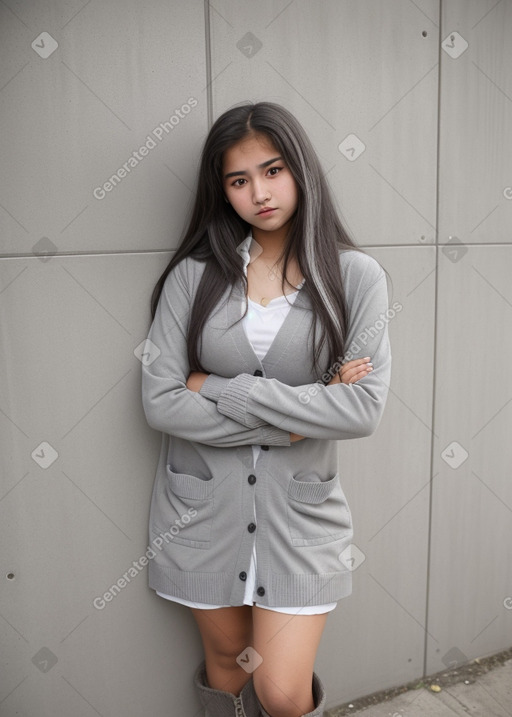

{"left": 143, "top": 102, "right": 391, "bottom": 717}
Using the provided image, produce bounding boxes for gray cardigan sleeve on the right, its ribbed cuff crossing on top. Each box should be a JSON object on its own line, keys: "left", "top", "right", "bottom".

{"left": 200, "top": 257, "right": 393, "bottom": 440}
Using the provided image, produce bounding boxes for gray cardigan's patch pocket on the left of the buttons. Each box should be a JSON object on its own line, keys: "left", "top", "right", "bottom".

{"left": 157, "top": 465, "right": 213, "bottom": 549}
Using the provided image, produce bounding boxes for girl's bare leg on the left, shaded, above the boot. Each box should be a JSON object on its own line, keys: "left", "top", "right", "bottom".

{"left": 191, "top": 605, "right": 252, "bottom": 696}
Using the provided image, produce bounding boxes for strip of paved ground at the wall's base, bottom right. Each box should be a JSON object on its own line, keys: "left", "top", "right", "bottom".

{"left": 325, "top": 659, "right": 512, "bottom": 717}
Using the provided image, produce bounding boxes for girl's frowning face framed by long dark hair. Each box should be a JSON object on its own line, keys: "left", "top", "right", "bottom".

{"left": 223, "top": 134, "right": 298, "bottom": 238}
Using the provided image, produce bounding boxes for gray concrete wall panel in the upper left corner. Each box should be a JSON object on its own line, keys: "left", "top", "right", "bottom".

{"left": 0, "top": 0, "right": 207, "bottom": 255}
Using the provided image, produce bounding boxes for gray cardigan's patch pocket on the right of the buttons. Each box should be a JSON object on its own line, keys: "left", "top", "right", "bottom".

{"left": 288, "top": 473, "right": 353, "bottom": 547}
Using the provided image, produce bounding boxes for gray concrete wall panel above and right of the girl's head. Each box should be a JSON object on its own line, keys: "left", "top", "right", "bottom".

{"left": 211, "top": 0, "right": 439, "bottom": 246}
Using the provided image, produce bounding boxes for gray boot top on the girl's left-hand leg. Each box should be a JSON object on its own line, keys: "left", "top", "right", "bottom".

{"left": 194, "top": 661, "right": 260, "bottom": 717}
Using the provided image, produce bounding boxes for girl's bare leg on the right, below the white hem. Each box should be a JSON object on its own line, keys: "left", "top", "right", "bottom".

{"left": 252, "top": 607, "right": 328, "bottom": 717}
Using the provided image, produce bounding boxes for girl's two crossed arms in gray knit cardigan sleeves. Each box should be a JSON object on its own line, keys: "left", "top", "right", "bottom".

{"left": 142, "top": 256, "right": 391, "bottom": 447}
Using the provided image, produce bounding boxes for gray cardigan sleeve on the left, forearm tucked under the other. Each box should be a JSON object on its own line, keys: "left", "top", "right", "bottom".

{"left": 142, "top": 260, "right": 290, "bottom": 447}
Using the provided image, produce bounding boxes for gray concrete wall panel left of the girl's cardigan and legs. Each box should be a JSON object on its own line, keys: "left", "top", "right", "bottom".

{"left": 0, "top": 253, "right": 201, "bottom": 717}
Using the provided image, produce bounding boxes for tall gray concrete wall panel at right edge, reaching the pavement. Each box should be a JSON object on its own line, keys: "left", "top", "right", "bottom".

{"left": 427, "top": 246, "right": 512, "bottom": 673}
